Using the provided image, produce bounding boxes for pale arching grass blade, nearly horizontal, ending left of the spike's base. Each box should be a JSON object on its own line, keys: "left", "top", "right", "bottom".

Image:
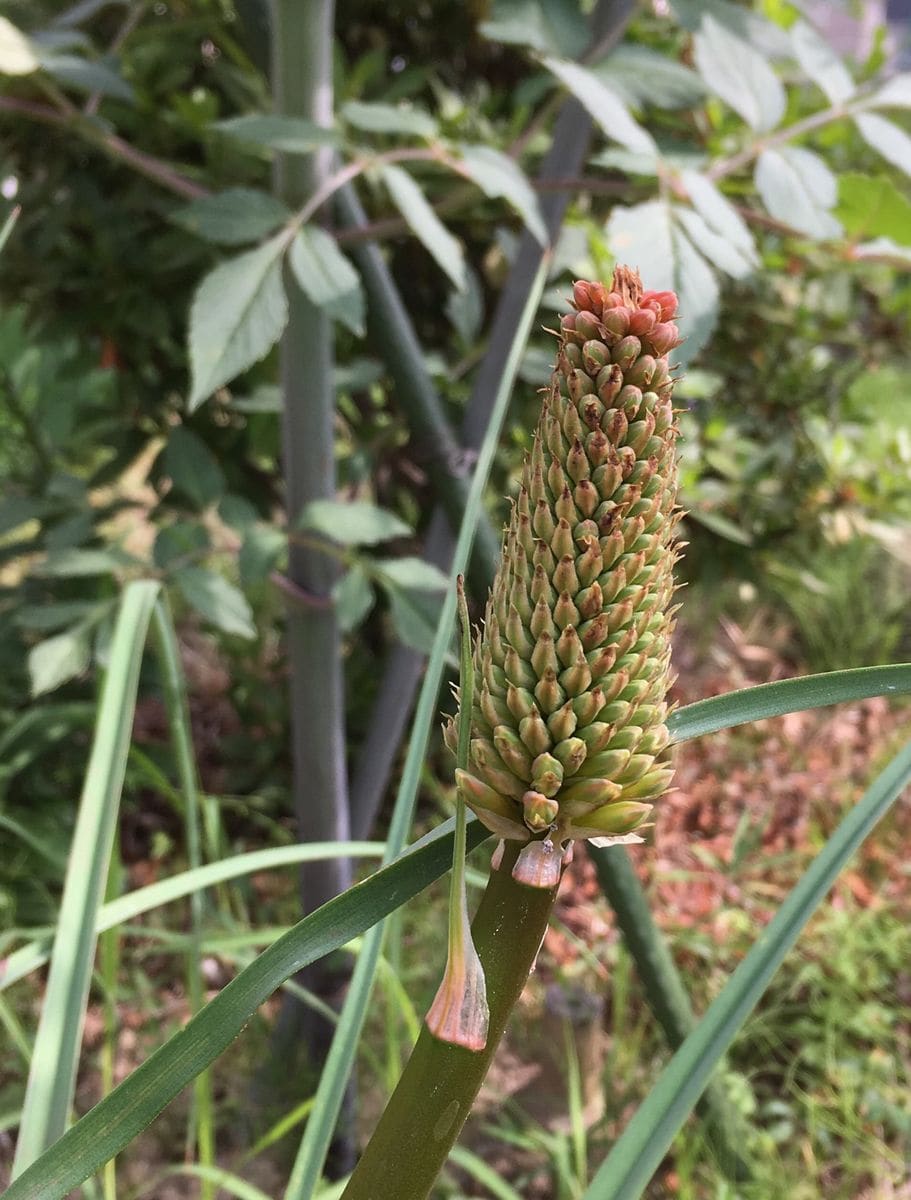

{"left": 0, "top": 841, "right": 385, "bottom": 991}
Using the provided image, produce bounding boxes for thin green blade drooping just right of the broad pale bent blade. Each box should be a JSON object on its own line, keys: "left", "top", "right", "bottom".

{"left": 152, "top": 596, "right": 215, "bottom": 1185}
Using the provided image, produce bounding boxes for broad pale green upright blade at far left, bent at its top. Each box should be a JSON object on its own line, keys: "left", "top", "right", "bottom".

{"left": 12, "top": 580, "right": 158, "bottom": 1180}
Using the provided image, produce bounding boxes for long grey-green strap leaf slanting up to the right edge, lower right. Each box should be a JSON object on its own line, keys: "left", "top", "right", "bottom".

{"left": 585, "top": 734, "right": 911, "bottom": 1200}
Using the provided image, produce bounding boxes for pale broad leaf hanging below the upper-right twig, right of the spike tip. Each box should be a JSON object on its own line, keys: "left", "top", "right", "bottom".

{"left": 755, "top": 146, "right": 841, "bottom": 238}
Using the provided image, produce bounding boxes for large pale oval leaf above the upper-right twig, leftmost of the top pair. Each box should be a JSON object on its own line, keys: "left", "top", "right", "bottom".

{"left": 694, "top": 13, "right": 786, "bottom": 133}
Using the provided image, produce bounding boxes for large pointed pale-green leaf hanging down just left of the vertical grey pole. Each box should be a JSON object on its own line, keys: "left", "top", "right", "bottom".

{"left": 188, "top": 234, "right": 288, "bottom": 412}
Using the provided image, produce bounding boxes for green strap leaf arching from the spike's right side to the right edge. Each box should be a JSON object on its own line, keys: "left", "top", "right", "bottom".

{"left": 667, "top": 662, "right": 911, "bottom": 742}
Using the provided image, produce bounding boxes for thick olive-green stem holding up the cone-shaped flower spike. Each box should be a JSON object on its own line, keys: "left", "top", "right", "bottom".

{"left": 342, "top": 842, "right": 556, "bottom": 1200}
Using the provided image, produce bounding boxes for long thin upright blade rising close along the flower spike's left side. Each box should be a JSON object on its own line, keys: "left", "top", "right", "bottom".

{"left": 286, "top": 257, "right": 550, "bottom": 1200}
